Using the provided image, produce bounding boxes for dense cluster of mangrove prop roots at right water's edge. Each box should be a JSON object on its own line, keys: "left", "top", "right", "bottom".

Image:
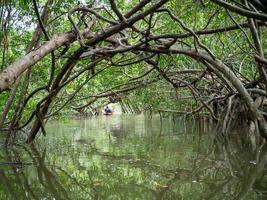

{"left": 213, "top": 94, "right": 267, "bottom": 139}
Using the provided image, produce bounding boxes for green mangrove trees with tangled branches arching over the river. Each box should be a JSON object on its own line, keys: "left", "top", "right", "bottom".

{"left": 0, "top": 0, "right": 267, "bottom": 143}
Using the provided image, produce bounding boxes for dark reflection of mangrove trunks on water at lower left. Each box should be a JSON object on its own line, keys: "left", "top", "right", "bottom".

{"left": 0, "top": 145, "right": 79, "bottom": 199}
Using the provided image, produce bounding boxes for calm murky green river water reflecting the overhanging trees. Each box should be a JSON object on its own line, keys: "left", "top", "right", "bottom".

{"left": 0, "top": 115, "right": 267, "bottom": 200}
